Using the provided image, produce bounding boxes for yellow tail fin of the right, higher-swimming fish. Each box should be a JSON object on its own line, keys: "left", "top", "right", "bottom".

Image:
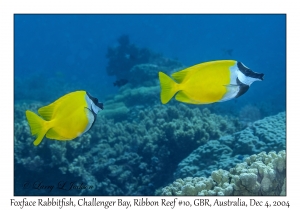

{"left": 158, "top": 72, "right": 179, "bottom": 104}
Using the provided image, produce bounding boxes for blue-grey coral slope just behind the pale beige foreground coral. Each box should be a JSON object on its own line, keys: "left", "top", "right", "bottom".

{"left": 174, "top": 112, "right": 286, "bottom": 178}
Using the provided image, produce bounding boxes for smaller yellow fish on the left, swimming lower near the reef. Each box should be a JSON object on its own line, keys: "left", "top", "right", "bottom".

{"left": 26, "top": 91, "right": 103, "bottom": 146}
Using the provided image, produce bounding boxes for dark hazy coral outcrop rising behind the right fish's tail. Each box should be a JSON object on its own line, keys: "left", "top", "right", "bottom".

{"left": 106, "top": 35, "right": 182, "bottom": 86}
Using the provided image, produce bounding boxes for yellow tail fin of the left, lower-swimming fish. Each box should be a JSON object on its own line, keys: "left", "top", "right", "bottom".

{"left": 26, "top": 110, "right": 49, "bottom": 146}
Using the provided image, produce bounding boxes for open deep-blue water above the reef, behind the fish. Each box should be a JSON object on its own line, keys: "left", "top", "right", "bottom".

{"left": 14, "top": 14, "right": 286, "bottom": 195}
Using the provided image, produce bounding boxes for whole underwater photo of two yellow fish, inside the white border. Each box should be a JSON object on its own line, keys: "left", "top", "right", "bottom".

{"left": 14, "top": 14, "right": 286, "bottom": 196}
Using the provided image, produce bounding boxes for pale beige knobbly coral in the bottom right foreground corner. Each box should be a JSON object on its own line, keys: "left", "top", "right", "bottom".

{"left": 156, "top": 150, "right": 286, "bottom": 196}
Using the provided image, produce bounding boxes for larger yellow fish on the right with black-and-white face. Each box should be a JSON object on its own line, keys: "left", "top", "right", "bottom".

{"left": 159, "top": 60, "right": 264, "bottom": 104}
